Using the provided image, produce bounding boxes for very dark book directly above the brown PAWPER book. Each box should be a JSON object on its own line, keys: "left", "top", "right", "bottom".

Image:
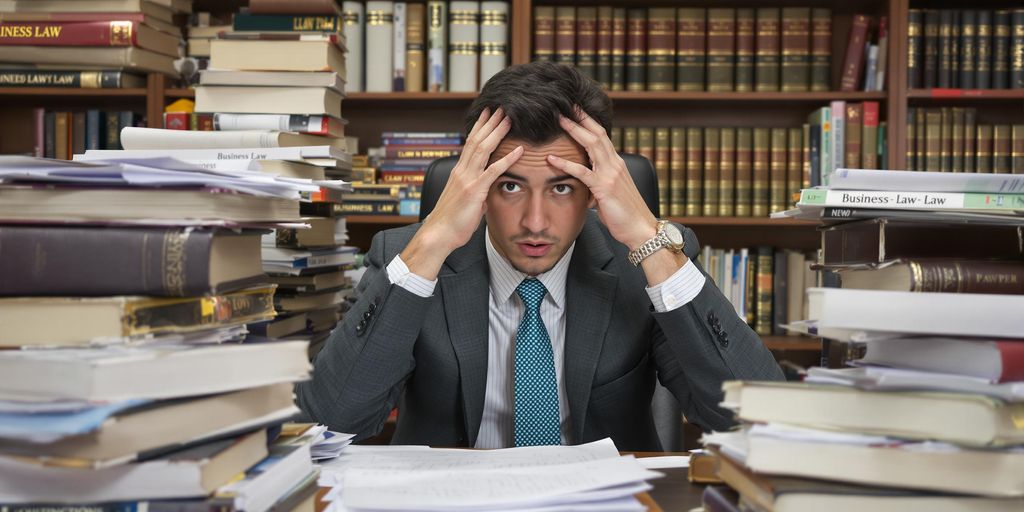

{"left": 821, "top": 218, "right": 1024, "bottom": 265}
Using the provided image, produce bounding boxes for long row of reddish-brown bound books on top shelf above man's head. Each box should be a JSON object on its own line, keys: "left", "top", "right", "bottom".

{"left": 532, "top": 5, "right": 888, "bottom": 91}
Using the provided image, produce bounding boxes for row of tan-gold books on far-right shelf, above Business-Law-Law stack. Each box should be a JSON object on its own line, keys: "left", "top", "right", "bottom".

{"left": 906, "top": 106, "right": 1024, "bottom": 174}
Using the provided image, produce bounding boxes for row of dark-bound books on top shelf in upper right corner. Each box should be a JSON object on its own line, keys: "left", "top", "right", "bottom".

{"left": 907, "top": 8, "right": 1024, "bottom": 89}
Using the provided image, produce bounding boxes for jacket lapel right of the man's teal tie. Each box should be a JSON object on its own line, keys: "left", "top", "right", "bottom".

{"left": 564, "top": 217, "right": 618, "bottom": 442}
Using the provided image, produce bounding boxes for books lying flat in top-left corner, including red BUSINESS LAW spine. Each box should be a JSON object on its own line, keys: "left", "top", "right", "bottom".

{"left": 0, "top": 0, "right": 193, "bottom": 80}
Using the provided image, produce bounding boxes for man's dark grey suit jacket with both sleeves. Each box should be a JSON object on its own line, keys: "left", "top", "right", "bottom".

{"left": 297, "top": 212, "right": 782, "bottom": 451}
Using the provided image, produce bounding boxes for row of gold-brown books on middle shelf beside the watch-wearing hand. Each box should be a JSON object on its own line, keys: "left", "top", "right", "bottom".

{"left": 610, "top": 101, "right": 886, "bottom": 217}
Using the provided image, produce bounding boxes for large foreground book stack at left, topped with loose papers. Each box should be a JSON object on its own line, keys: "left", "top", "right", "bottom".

{"left": 0, "top": 157, "right": 315, "bottom": 510}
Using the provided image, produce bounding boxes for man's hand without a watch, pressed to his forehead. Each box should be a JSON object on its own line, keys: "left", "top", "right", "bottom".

{"left": 393, "top": 108, "right": 523, "bottom": 280}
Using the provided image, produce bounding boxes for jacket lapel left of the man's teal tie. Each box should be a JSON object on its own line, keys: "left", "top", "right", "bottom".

{"left": 438, "top": 225, "right": 489, "bottom": 446}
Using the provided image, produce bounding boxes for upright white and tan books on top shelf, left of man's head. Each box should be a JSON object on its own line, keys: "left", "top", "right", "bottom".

{"left": 342, "top": 0, "right": 511, "bottom": 92}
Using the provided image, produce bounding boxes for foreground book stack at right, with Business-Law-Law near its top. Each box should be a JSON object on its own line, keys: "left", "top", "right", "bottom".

{"left": 706, "top": 166, "right": 1024, "bottom": 511}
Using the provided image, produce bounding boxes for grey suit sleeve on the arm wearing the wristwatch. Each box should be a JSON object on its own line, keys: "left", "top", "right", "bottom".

{"left": 652, "top": 228, "right": 784, "bottom": 430}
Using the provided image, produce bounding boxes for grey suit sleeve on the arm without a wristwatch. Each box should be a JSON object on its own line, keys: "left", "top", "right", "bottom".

{"left": 296, "top": 231, "right": 430, "bottom": 440}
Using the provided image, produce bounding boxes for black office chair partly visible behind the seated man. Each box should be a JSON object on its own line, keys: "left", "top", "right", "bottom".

{"left": 411, "top": 154, "right": 683, "bottom": 452}
